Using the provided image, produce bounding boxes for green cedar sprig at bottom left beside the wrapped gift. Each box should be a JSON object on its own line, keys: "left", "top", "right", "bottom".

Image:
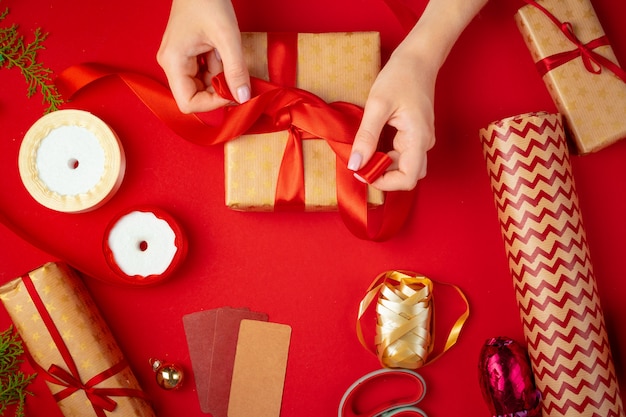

{"left": 0, "top": 326, "right": 37, "bottom": 417}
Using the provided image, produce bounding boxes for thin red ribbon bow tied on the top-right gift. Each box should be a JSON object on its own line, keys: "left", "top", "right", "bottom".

{"left": 525, "top": 0, "right": 626, "bottom": 82}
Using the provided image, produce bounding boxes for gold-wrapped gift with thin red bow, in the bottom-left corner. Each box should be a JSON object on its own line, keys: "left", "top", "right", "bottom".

{"left": 0, "top": 263, "right": 155, "bottom": 417}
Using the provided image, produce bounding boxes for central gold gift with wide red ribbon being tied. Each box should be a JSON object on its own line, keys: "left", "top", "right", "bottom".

{"left": 56, "top": 32, "right": 415, "bottom": 241}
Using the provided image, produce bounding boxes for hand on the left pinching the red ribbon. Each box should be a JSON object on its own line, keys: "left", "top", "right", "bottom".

{"left": 157, "top": 0, "right": 250, "bottom": 113}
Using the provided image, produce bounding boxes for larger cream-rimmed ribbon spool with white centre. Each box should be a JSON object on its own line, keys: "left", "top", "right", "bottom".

{"left": 18, "top": 110, "right": 126, "bottom": 213}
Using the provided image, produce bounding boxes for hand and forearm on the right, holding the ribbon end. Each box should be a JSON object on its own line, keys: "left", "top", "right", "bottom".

{"left": 348, "top": 0, "right": 487, "bottom": 191}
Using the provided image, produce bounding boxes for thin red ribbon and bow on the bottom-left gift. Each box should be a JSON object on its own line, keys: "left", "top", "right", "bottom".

{"left": 22, "top": 275, "right": 147, "bottom": 417}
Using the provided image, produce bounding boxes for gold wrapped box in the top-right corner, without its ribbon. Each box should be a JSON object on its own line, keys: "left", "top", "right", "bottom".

{"left": 515, "top": 0, "right": 626, "bottom": 155}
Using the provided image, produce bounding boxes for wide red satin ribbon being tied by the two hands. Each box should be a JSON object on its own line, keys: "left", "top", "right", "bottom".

{"left": 57, "top": 54, "right": 414, "bottom": 240}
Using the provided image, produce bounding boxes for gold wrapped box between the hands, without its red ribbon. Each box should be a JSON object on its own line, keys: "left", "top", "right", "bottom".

{"left": 224, "top": 32, "right": 383, "bottom": 211}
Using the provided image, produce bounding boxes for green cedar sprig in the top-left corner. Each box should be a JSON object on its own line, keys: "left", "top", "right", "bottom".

{"left": 0, "top": 8, "right": 63, "bottom": 113}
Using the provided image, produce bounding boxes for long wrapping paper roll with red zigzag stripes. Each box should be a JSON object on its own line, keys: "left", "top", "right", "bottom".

{"left": 480, "top": 113, "right": 624, "bottom": 417}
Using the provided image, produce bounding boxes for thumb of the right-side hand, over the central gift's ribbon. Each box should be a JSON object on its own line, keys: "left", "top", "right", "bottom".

{"left": 348, "top": 102, "right": 387, "bottom": 171}
